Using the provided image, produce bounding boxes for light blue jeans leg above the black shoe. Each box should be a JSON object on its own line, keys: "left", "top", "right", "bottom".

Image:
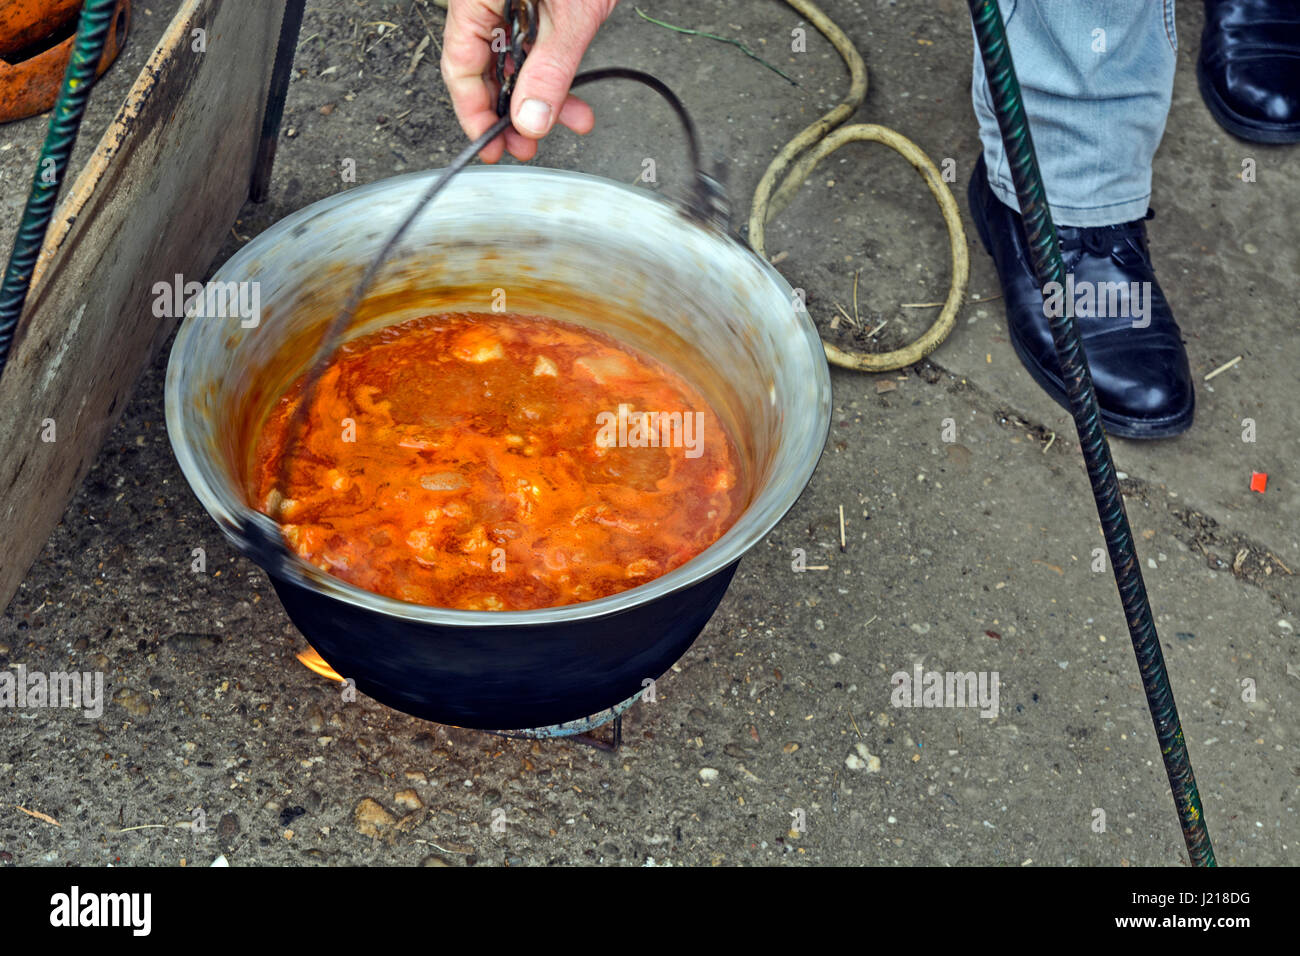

{"left": 971, "top": 0, "right": 1178, "bottom": 226}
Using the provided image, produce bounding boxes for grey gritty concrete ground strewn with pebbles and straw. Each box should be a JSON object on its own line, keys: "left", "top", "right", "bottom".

{"left": 0, "top": 0, "right": 1300, "bottom": 866}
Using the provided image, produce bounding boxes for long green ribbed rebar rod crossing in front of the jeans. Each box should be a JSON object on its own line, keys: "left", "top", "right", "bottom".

{"left": 969, "top": 0, "right": 1214, "bottom": 866}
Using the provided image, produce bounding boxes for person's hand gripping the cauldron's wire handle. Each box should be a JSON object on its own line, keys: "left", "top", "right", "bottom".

{"left": 442, "top": 0, "right": 618, "bottom": 163}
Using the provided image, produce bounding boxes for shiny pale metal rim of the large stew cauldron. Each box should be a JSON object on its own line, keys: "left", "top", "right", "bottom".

{"left": 165, "top": 166, "right": 831, "bottom": 628}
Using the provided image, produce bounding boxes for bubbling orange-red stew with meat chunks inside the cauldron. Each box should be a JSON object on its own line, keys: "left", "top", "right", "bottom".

{"left": 251, "top": 312, "right": 748, "bottom": 610}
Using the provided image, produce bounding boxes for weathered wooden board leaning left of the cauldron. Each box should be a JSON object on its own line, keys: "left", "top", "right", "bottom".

{"left": 0, "top": 0, "right": 285, "bottom": 607}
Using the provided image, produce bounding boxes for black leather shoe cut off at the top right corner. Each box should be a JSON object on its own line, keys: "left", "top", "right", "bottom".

{"left": 1196, "top": 0, "right": 1300, "bottom": 143}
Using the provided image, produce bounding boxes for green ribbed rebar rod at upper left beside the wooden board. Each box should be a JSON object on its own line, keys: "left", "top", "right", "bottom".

{"left": 0, "top": 0, "right": 117, "bottom": 375}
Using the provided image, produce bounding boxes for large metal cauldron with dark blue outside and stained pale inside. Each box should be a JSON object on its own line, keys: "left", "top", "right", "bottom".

{"left": 166, "top": 166, "right": 831, "bottom": 730}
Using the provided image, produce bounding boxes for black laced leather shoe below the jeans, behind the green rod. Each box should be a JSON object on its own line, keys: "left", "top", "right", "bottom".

{"left": 969, "top": 155, "right": 1196, "bottom": 438}
